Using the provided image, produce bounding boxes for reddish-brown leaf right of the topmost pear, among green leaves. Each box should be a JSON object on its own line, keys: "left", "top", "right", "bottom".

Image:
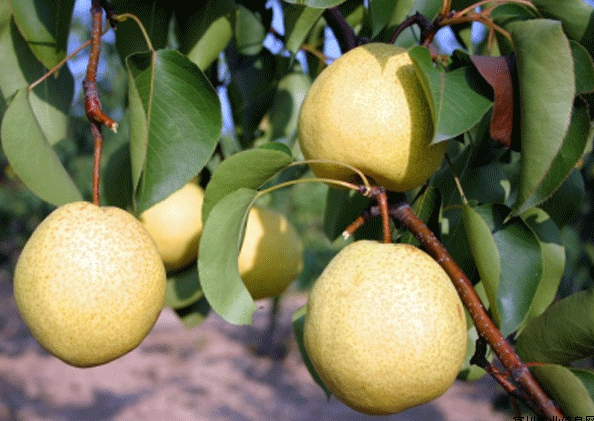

{"left": 470, "top": 56, "right": 514, "bottom": 148}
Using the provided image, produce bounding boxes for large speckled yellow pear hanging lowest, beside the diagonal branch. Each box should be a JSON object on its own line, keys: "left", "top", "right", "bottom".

{"left": 304, "top": 240, "right": 467, "bottom": 414}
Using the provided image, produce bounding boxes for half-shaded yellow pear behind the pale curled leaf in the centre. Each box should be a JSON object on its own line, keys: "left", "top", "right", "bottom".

{"left": 238, "top": 207, "right": 303, "bottom": 300}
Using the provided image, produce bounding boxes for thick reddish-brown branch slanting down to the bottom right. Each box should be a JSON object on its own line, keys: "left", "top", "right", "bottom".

{"left": 390, "top": 200, "right": 563, "bottom": 420}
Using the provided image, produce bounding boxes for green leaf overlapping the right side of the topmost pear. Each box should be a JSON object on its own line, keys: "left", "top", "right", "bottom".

{"left": 409, "top": 47, "right": 493, "bottom": 143}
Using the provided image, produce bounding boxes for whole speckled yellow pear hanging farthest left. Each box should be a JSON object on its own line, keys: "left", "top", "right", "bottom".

{"left": 14, "top": 202, "right": 166, "bottom": 367}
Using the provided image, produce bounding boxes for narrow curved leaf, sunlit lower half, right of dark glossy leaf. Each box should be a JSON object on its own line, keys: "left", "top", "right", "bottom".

{"left": 519, "top": 208, "right": 565, "bottom": 331}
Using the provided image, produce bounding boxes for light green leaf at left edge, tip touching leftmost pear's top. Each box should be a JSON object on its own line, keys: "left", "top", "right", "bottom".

{"left": 0, "top": 88, "right": 82, "bottom": 206}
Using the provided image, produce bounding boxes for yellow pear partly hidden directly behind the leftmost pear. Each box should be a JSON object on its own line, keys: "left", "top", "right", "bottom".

{"left": 139, "top": 181, "right": 204, "bottom": 272}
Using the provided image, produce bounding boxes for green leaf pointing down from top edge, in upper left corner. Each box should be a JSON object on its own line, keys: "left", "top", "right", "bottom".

{"left": 10, "top": 0, "right": 74, "bottom": 69}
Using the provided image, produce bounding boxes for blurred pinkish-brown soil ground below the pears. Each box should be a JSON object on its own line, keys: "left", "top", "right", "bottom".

{"left": 0, "top": 270, "right": 514, "bottom": 421}
